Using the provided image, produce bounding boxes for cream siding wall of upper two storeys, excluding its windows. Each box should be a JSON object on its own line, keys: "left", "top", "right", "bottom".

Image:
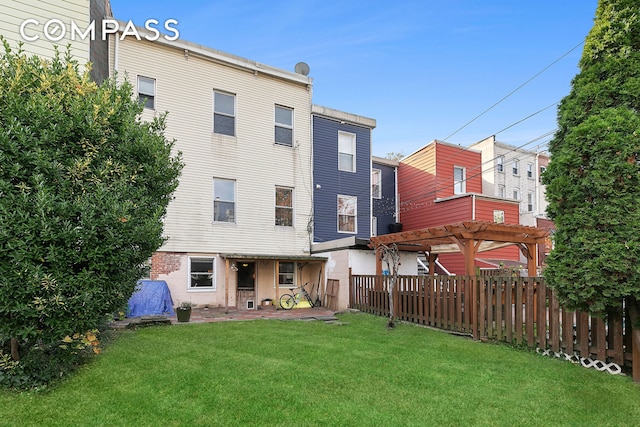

{"left": 117, "top": 37, "right": 312, "bottom": 255}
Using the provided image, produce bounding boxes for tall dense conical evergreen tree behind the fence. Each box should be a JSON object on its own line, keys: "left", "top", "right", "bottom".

{"left": 543, "top": 0, "right": 640, "bottom": 314}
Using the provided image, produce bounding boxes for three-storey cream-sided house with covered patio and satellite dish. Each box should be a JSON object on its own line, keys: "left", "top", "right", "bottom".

{"left": 110, "top": 24, "right": 324, "bottom": 309}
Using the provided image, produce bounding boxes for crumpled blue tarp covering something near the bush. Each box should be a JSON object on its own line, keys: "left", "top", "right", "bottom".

{"left": 127, "top": 280, "right": 175, "bottom": 317}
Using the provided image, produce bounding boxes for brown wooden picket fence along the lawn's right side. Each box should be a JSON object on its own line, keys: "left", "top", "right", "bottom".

{"left": 349, "top": 275, "right": 640, "bottom": 381}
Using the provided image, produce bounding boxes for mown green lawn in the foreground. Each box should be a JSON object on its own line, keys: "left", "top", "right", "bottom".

{"left": 0, "top": 314, "right": 640, "bottom": 426}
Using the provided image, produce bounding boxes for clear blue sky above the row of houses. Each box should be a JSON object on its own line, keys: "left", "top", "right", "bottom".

{"left": 111, "top": 0, "right": 598, "bottom": 157}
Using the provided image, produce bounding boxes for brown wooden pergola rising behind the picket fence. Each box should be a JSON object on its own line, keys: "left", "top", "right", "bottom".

{"left": 369, "top": 221, "right": 549, "bottom": 276}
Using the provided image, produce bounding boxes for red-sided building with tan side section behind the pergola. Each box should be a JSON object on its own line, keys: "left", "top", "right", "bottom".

{"left": 398, "top": 140, "right": 526, "bottom": 274}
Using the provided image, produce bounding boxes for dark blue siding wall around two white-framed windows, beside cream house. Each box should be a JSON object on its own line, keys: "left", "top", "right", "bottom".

{"left": 313, "top": 116, "right": 371, "bottom": 242}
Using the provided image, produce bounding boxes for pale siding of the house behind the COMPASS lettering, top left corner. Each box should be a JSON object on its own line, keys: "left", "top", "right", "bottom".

{"left": 0, "top": 0, "right": 90, "bottom": 65}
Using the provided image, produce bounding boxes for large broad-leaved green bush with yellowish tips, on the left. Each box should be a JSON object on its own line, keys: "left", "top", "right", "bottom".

{"left": 0, "top": 42, "right": 182, "bottom": 388}
